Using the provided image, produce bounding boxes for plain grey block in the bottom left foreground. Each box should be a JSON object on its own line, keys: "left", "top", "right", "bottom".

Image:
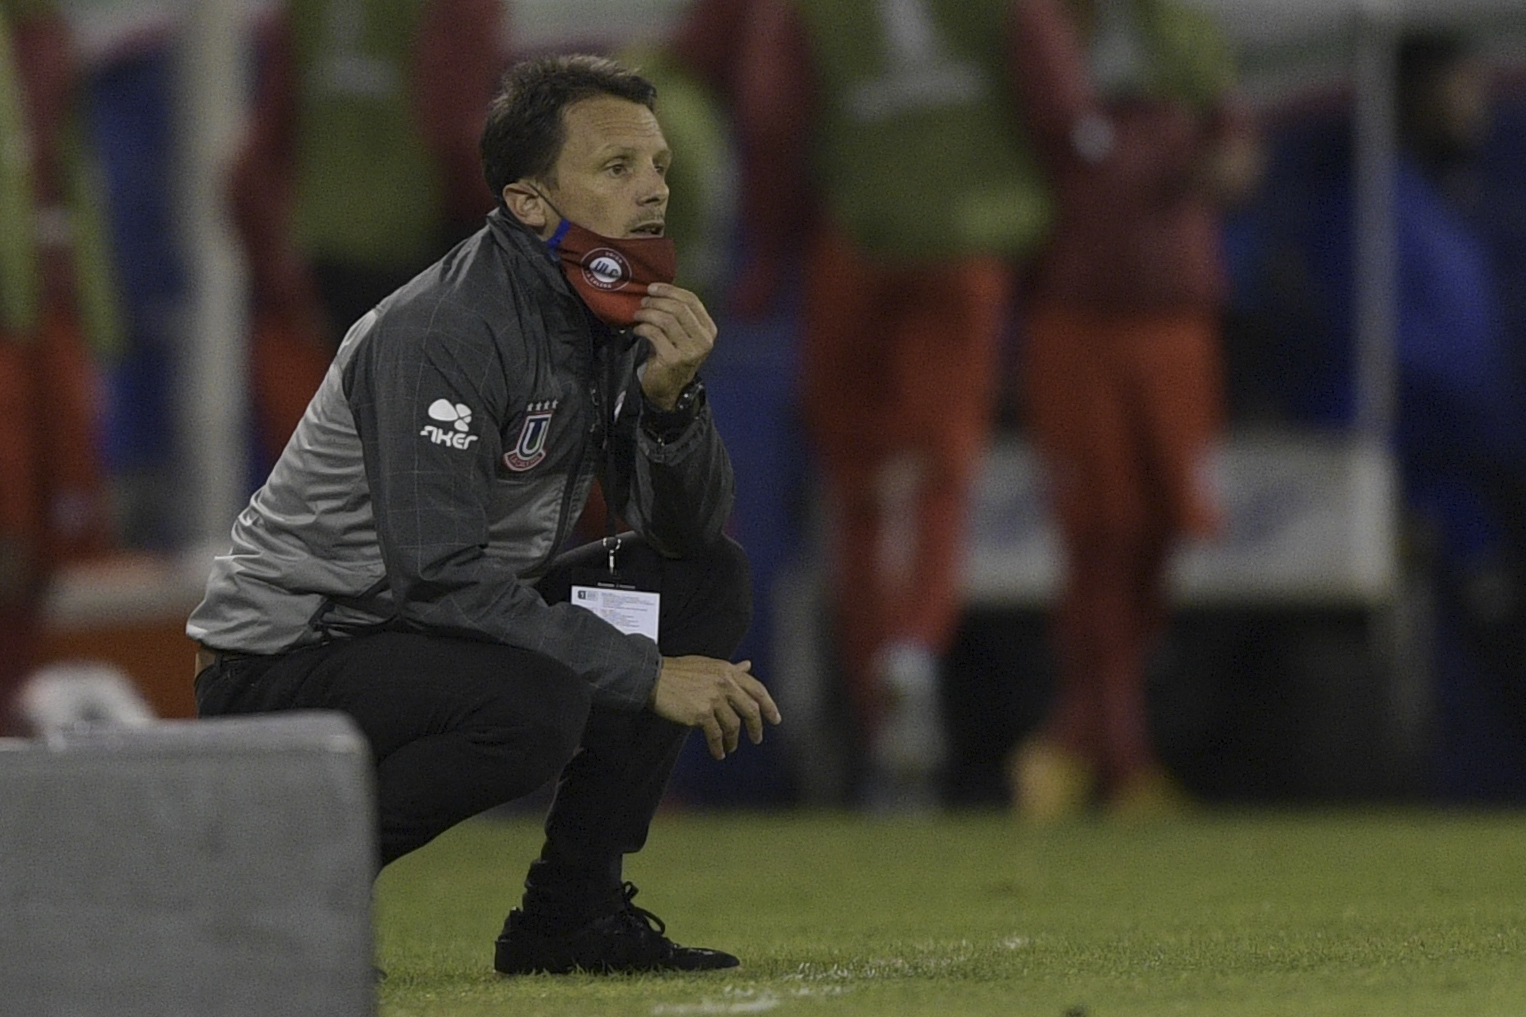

{"left": 0, "top": 713, "right": 375, "bottom": 1017}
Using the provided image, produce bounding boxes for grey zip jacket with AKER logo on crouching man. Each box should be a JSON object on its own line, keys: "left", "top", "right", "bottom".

{"left": 186, "top": 209, "right": 732, "bottom": 709}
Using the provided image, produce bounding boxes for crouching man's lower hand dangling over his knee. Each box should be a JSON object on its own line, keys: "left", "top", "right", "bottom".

{"left": 652, "top": 655, "right": 780, "bottom": 759}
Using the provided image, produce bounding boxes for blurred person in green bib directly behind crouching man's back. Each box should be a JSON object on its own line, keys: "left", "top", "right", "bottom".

{"left": 229, "top": 0, "right": 507, "bottom": 458}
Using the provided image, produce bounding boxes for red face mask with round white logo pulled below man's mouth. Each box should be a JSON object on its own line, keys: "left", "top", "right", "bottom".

{"left": 546, "top": 218, "right": 678, "bottom": 328}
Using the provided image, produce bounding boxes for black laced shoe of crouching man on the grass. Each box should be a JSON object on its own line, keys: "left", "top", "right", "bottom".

{"left": 493, "top": 883, "right": 740, "bottom": 974}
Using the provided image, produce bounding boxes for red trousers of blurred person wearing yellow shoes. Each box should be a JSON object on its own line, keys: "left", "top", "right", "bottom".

{"left": 1022, "top": 304, "right": 1222, "bottom": 780}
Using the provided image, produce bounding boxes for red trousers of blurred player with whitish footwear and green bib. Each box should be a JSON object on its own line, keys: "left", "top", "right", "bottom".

{"left": 803, "top": 234, "right": 1010, "bottom": 730}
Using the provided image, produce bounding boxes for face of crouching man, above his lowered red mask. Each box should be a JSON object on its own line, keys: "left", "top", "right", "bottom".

{"left": 540, "top": 96, "right": 671, "bottom": 237}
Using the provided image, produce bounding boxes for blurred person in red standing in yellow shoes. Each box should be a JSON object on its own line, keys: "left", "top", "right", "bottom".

{"left": 1009, "top": 0, "right": 1259, "bottom": 822}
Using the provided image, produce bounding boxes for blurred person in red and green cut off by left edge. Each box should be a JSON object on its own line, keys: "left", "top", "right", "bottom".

{"left": 0, "top": 0, "right": 121, "bottom": 727}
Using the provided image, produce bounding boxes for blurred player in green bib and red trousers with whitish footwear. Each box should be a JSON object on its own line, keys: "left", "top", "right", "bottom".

{"left": 674, "top": 0, "right": 1048, "bottom": 806}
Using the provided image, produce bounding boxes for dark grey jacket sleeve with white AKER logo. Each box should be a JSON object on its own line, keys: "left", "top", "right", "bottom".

{"left": 345, "top": 307, "right": 661, "bottom": 710}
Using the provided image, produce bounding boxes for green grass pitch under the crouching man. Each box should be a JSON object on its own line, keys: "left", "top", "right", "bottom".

{"left": 377, "top": 811, "right": 1526, "bottom": 1017}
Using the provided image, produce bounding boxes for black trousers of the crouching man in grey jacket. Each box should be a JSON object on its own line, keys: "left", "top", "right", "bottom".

{"left": 195, "top": 538, "right": 752, "bottom": 909}
